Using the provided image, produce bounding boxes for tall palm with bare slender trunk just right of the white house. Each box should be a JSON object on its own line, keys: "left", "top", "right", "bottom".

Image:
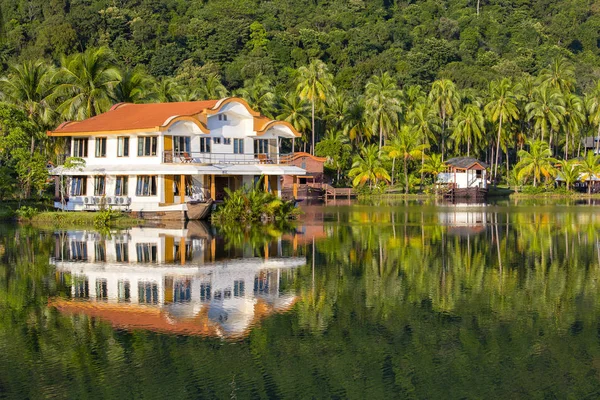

{"left": 296, "top": 59, "right": 333, "bottom": 152}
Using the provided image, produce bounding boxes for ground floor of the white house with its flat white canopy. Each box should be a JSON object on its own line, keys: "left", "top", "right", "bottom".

{"left": 52, "top": 165, "right": 305, "bottom": 213}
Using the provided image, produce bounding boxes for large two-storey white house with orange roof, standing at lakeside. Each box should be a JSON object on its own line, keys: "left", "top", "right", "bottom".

{"left": 48, "top": 98, "right": 306, "bottom": 220}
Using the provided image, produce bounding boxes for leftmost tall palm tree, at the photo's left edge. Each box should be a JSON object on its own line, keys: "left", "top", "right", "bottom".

{"left": 0, "top": 61, "right": 54, "bottom": 155}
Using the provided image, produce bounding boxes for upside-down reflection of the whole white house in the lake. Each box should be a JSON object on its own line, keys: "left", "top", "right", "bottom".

{"left": 51, "top": 226, "right": 306, "bottom": 338}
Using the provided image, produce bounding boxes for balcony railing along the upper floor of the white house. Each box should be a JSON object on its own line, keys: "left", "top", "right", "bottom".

{"left": 163, "top": 151, "right": 293, "bottom": 164}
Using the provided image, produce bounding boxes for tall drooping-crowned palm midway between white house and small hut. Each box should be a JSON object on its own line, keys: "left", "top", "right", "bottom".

{"left": 365, "top": 72, "right": 402, "bottom": 150}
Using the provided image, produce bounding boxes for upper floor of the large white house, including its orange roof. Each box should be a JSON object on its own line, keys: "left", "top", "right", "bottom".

{"left": 48, "top": 97, "right": 300, "bottom": 166}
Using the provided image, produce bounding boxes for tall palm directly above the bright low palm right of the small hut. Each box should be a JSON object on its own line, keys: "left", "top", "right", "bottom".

{"left": 525, "top": 85, "right": 565, "bottom": 147}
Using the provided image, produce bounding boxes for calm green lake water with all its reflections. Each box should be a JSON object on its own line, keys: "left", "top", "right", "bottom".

{"left": 0, "top": 201, "right": 600, "bottom": 399}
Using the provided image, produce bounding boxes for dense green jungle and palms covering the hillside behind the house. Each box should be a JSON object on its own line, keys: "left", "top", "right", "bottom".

{"left": 0, "top": 0, "right": 600, "bottom": 197}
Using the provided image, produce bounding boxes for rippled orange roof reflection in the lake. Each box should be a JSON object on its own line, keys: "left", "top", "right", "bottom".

{"left": 48, "top": 297, "right": 297, "bottom": 338}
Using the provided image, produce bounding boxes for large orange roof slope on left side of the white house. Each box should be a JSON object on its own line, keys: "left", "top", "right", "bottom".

{"left": 50, "top": 100, "right": 218, "bottom": 134}
